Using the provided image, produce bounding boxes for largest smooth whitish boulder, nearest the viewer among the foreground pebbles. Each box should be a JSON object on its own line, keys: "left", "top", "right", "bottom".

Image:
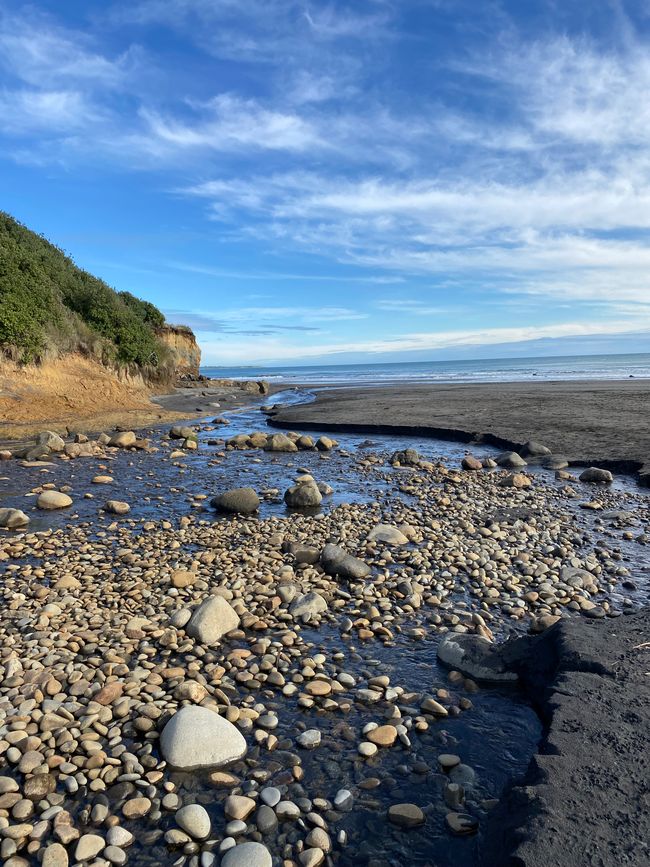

{"left": 160, "top": 705, "right": 247, "bottom": 771}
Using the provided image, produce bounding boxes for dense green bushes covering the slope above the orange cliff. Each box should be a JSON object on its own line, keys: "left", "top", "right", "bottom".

{"left": 0, "top": 211, "right": 168, "bottom": 371}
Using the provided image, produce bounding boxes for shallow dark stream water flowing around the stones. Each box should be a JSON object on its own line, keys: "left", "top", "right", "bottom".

{"left": 0, "top": 390, "right": 650, "bottom": 867}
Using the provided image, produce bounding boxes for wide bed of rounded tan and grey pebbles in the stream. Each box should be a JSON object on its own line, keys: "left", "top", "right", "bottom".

{"left": 0, "top": 424, "right": 647, "bottom": 867}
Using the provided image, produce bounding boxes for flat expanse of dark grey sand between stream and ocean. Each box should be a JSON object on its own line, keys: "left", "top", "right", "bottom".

{"left": 270, "top": 380, "right": 650, "bottom": 472}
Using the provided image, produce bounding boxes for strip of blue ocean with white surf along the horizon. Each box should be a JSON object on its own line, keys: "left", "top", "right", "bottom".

{"left": 201, "top": 353, "right": 650, "bottom": 385}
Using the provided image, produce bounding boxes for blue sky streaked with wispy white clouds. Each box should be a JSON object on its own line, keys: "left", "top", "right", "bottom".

{"left": 0, "top": 0, "right": 650, "bottom": 365}
